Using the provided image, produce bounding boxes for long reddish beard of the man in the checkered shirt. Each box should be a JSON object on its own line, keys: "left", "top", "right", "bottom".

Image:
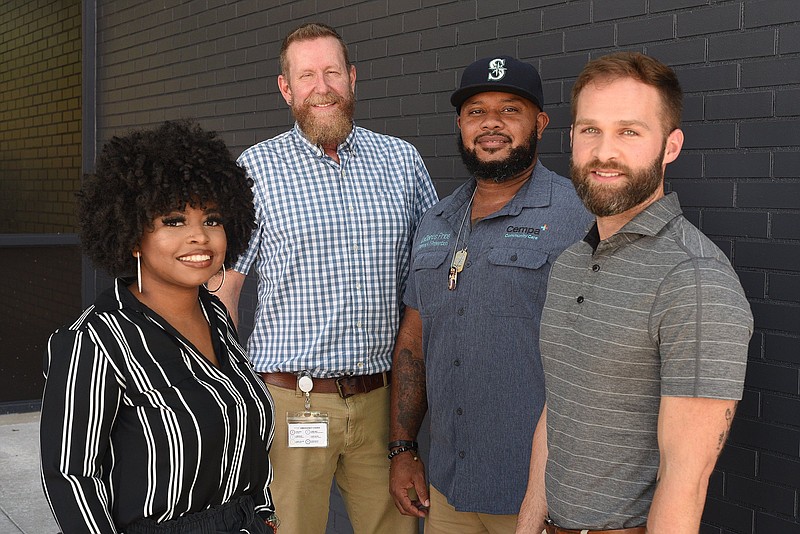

{"left": 292, "top": 91, "right": 356, "bottom": 147}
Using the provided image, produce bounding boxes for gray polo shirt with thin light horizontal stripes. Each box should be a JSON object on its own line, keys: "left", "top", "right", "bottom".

{"left": 541, "top": 193, "right": 753, "bottom": 529}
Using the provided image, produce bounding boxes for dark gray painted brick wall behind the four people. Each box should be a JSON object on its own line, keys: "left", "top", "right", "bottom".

{"left": 90, "top": 0, "right": 800, "bottom": 534}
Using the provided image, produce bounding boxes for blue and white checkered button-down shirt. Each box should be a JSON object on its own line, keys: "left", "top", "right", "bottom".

{"left": 234, "top": 125, "right": 437, "bottom": 378}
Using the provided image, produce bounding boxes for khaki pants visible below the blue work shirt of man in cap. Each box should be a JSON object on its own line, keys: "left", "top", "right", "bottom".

{"left": 425, "top": 486, "right": 517, "bottom": 534}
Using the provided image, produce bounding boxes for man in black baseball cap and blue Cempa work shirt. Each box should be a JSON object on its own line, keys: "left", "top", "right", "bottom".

{"left": 389, "top": 56, "right": 591, "bottom": 534}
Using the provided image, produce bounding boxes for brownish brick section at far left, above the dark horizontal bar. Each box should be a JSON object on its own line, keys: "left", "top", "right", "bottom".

{"left": 0, "top": 0, "right": 81, "bottom": 234}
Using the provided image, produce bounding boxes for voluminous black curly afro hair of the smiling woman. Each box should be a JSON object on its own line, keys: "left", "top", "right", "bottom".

{"left": 78, "top": 120, "right": 255, "bottom": 276}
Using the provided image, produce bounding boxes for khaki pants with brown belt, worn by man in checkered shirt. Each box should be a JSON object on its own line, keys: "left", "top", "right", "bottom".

{"left": 267, "top": 384, "right": 418, "bottom": 534}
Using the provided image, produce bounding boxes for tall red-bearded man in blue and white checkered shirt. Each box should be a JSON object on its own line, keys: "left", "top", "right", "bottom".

{"left": 220, "top": 23, "right": 437, "bottom": 534}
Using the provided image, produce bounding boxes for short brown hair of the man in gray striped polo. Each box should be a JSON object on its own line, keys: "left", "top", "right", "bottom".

{"left": 572, "top": 52, "right": 683, "bottom": 134}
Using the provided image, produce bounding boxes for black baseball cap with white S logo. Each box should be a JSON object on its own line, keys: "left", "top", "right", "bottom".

{"left": 450, "top": 56, "right": 544, "bottom": 113}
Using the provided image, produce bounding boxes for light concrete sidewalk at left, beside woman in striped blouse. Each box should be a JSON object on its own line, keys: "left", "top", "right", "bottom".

{"left": 0, "top": 412, "right": 59, "bottom": 534}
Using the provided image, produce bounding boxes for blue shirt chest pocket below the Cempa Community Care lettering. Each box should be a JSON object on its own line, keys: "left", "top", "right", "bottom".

{"left": 482, "top": 247, "right": 550, "bottom": 318}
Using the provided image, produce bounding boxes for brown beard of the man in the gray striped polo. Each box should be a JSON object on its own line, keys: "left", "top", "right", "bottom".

{"left": 569, "top": 144, "right": 666, "bottom": 217}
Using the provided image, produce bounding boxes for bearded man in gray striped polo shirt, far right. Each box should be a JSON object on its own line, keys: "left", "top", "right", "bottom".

{"left": 517, "top": 53, "right": 753, "bottom": 534}
